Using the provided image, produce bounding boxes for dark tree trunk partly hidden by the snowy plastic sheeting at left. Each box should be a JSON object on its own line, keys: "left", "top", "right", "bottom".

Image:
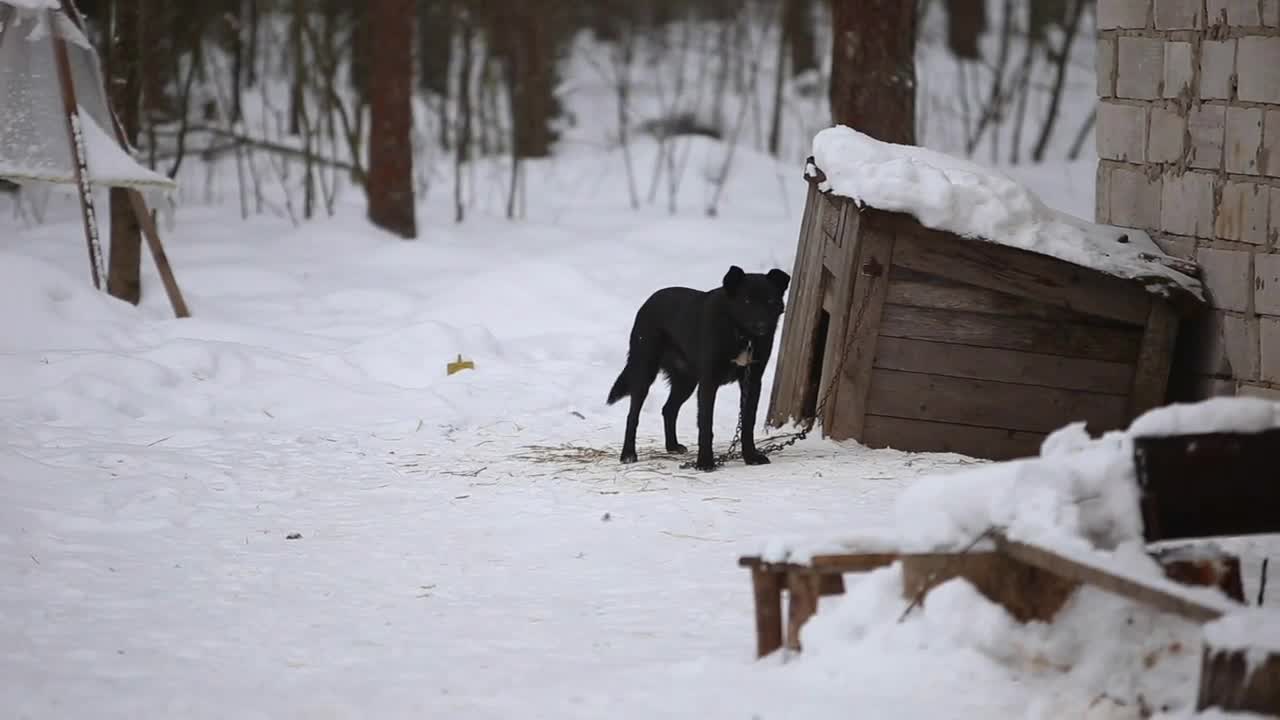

{"left": 106, "top": 0, "right": 142, "bottom": 305}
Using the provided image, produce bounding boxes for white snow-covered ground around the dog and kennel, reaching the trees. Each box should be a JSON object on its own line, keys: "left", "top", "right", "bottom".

{"left": 0, "top": 4, "right": 1263, "bottom": 720}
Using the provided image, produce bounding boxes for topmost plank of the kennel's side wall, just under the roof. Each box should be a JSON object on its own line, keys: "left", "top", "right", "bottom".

{"left": 876, "top": 214, "right": 1151, "bottom": 324}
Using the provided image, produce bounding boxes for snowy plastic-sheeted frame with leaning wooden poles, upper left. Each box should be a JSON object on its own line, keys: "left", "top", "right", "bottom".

{"left": 0, "top": 0, "right": 189, "bottom": 318}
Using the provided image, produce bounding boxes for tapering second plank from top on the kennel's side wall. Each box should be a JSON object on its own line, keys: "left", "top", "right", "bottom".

{"left": 886, "top": 264, "right": 1138, "bottom": 327}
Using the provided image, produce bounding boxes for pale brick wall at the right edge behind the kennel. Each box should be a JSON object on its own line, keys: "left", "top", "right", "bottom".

{"left": 1097, "top": 0, "right": 1280, "bottom": 400}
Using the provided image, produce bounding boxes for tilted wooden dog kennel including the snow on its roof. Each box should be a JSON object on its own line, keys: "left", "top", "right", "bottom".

{"left": 768, "top": 127, "right": 1203, "bottom": 459}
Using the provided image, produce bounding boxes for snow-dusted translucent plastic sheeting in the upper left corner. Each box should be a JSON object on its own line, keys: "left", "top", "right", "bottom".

{"left": 0, "top": 0, "right": 175, "bottom": 188}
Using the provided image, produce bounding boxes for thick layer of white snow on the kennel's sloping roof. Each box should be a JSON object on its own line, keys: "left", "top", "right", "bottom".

{"left": 805, "top": 126, "right": 1204, "bottom": 300}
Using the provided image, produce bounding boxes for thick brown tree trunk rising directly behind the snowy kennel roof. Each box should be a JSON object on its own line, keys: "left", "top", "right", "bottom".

{"left": 831, "top": 0, "right": 915, "bottom": 145}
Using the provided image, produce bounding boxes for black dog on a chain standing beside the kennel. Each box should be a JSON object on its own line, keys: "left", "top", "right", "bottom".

{"left": 608, "top": 265, "right": 791, "bottom": 470}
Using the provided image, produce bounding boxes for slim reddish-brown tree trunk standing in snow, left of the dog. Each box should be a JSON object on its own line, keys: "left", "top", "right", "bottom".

{"left": 365, "top": 0, "right": 417, "bottom": 240}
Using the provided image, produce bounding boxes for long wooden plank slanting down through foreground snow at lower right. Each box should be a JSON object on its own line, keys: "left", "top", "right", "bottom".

{"left": 995, "top": 533, "right": 1223, "bottom": 623}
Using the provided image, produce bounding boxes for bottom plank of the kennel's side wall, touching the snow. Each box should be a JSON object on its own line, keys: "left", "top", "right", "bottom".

{"left": 861, "top": 415, "right": 1044, "bottom": 460}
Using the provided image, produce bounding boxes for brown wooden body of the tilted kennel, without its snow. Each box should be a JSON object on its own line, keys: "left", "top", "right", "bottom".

{"left": 768, "top": 165, "right": 1199, "bottom": 460}
